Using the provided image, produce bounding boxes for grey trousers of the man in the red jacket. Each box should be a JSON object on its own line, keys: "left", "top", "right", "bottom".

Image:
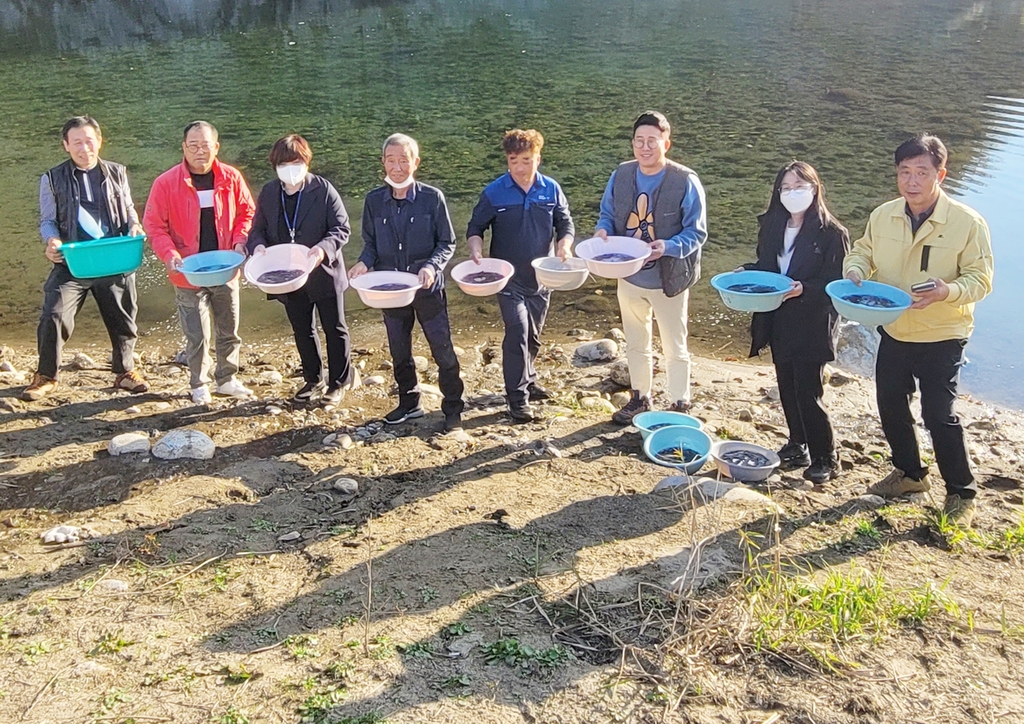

{"left": 174, "top": 279, "right": 242, "bottom": 389}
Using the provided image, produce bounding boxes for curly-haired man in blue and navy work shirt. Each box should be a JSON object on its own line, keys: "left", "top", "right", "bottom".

{"left": 466, "top": 128, "right": 575, "bottom": 422}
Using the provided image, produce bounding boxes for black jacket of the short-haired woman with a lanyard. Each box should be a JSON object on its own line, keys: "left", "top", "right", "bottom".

{"left": 246, "top": 173, "right": 351, "bottom": 301}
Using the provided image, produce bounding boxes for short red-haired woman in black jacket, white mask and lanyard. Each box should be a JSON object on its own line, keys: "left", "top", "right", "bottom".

{"left": 247, "top": 134, "right": 351, "bottom": 404}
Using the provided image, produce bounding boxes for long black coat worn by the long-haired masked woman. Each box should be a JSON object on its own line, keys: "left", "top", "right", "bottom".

{"left": 744, "top": 223, "right": 850, "bottom": 364}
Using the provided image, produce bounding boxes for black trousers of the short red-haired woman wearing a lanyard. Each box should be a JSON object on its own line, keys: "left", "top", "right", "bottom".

{"left": 279, "top": 292, "right": 352, "bottom": 389}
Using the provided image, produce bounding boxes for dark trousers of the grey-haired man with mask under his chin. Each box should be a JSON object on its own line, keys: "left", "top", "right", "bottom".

{"left": 382, "top": 289, "right": 466, "bottom": 415}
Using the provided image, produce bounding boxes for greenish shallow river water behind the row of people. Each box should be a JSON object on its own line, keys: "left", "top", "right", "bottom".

{"left": 0, "top": 0, "right": 1024, "bottom": 407}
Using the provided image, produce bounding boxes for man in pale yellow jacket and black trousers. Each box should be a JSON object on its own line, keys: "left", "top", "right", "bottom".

{"left": 843, "top": 135, "right": 992, "bottom": 526}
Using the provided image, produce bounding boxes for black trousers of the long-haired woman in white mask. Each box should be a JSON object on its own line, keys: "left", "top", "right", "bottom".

{"left": 775, "top": 357, "right": 836, "bottom": 460}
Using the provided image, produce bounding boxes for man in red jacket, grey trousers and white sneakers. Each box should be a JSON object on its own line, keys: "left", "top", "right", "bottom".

{"left": 142, "top": 121, "right": 255, "bottom": 404}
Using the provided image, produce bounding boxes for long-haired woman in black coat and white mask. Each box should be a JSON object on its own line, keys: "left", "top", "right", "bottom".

{"left": 744, "top": 161, "right": 850, "bottom": 484}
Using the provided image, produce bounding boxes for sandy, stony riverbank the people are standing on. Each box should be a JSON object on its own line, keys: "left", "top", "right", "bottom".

{"left": 0, "top": 326, "right": 1024, "bottom": 724}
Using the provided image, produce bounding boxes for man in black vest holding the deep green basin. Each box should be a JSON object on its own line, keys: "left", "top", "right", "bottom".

{"left": 22, "top": 116, "right": 150, "bottom": 400}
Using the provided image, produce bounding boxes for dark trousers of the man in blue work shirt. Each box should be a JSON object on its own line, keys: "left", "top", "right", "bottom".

{"left": 498, "top": 289, "right": 551, "bottom": 406}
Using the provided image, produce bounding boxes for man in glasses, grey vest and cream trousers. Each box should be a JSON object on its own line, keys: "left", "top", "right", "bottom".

{"left": 596, "top": 111, "right": 708, "bottom": 425}
